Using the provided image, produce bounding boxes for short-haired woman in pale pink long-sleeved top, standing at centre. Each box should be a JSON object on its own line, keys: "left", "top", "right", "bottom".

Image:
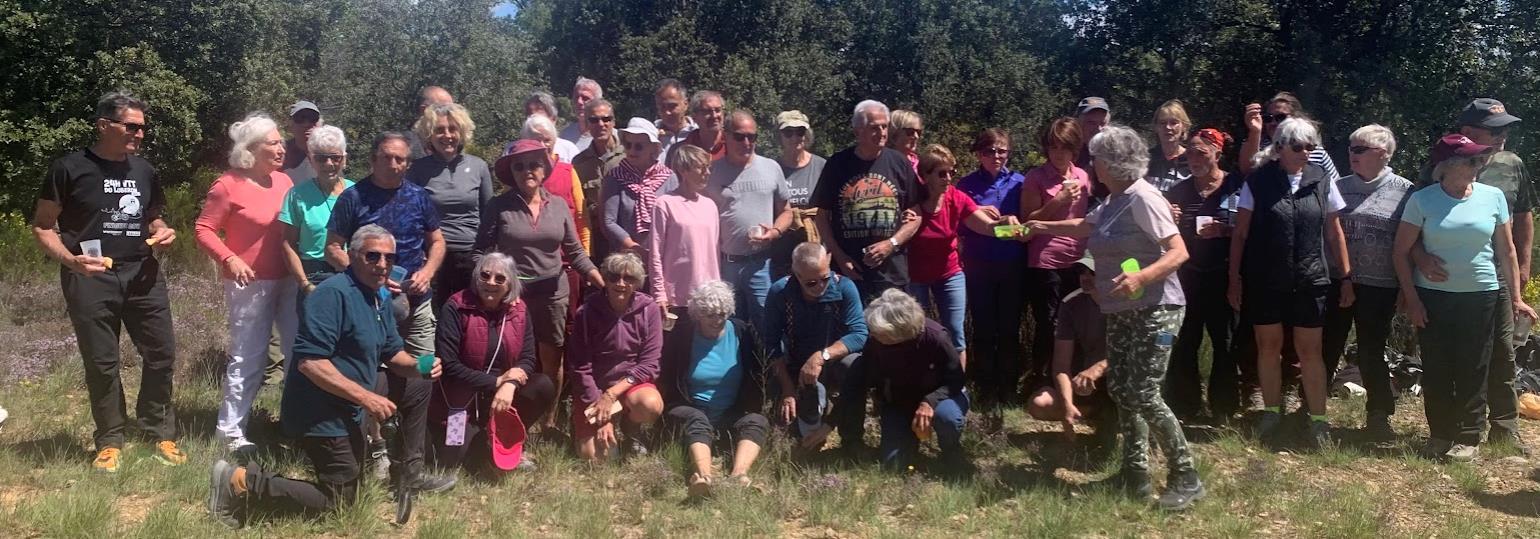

{"left": 647, "top": 145, "right": 721, "bottom": 317}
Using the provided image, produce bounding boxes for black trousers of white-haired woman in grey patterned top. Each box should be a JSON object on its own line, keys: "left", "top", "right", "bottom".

{"left": 1321, "top": 282, "right": 1400, "bottom": 416}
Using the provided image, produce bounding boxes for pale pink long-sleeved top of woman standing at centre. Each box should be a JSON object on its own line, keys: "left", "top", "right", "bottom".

{"left": 648, "top": 193, "right": 722, "bottom": 306}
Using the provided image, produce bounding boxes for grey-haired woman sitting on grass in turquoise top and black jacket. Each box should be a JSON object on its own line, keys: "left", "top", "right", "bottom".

{"left": 658, "top": 280, "right": 770, "bottom": 496}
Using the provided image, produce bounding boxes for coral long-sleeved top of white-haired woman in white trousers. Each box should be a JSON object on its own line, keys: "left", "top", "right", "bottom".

{"left": 193, "top": 171, "right": 294, "bottom": 280}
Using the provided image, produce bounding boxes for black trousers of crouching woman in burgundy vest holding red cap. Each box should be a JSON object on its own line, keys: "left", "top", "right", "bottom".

{"left": 428, "top": 373, "right": 556, "bottom": 470}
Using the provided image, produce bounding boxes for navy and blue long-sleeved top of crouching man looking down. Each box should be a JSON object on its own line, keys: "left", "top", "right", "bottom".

{"left": 765, "top": 273, "right": 867, "bottom": 370}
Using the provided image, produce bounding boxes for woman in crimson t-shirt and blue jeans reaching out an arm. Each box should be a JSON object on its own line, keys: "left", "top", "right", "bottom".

{"left": 909, "top": 145, "right": 1015, "bottom": 368}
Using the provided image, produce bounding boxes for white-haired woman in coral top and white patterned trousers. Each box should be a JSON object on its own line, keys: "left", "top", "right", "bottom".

{"left": 194, "top": 114, "right": 299, "bottom": 451}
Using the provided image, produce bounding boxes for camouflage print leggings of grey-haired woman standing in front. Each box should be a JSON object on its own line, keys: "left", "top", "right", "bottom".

{"left": 1107, "top": 305, "right": 1192, "bottom": 473}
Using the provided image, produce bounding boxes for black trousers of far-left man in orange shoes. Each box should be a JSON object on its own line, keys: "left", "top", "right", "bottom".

{"left": 59, "top": 257, "right": 177, "bottom": 450}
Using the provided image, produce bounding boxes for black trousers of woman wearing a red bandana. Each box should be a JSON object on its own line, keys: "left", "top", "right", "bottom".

{"left": 1163, "top": 270, "right": 1255, "bottom": 417}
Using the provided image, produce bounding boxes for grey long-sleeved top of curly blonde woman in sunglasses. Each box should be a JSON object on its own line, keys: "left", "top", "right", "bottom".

{"left": 407, "top": 154, "right": 493, "bottom": 251}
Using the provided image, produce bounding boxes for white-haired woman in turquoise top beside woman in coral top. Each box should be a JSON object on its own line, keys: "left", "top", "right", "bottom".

{"left": 279, "top": 125, "right": 353, "bottom": 297}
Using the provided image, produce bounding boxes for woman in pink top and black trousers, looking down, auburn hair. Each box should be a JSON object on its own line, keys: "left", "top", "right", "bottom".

{"left": 1021, "top": 117, "right": 1092, "bottom": 376}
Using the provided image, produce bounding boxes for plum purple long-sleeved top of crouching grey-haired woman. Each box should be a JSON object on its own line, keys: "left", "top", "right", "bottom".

{"left": 567, "top": 294, "right": 664, "bottom": 405}
